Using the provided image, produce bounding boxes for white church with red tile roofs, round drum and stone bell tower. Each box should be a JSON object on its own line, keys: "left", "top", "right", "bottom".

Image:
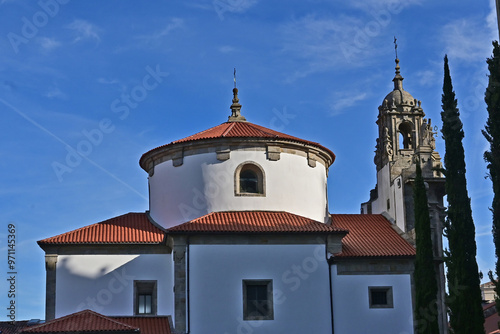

{"left": 38, "top": 60, "right": 447, "bottom": 334}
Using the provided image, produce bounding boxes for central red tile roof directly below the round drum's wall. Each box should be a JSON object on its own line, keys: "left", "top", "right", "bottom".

{"left": 167, "top": 211, "right": 347, "bottom": 233}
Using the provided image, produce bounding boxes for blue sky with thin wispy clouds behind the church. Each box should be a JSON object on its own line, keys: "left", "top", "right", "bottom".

{"left": 0, "top": 0, "right": 498, "bottom": 320}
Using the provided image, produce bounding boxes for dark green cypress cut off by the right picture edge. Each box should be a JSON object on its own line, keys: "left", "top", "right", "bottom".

{"left": 483, "top": 41, "right": 500, "bottom": 306}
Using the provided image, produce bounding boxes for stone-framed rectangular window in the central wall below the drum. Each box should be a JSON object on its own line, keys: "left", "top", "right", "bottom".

{"left": 243, "top": 280, "right": 274, "bottom": 320}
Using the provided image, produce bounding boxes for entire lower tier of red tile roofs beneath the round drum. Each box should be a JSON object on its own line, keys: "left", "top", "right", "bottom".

{"left": 38, "top": 211, "right": 415, "bottom": 259}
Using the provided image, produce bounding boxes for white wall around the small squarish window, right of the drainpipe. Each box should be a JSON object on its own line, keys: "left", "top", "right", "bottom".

{"left": 332, "top": 265, "right": 413, "bottom": 334}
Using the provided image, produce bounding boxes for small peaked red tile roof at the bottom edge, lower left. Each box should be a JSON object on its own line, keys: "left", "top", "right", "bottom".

{"left": 22, "top": 310, "right": 139, "bottom": 333}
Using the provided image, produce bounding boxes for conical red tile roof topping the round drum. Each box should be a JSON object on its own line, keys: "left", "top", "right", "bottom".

{"left": 139, "top": 122, "right": 335, "bottom": 166}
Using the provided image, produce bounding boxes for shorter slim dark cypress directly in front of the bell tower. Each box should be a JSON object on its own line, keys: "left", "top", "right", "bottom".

{"left": 413, "top": 163, "right": 439, "bottom": 334}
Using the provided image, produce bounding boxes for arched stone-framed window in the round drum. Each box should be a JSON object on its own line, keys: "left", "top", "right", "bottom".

{"left": 234, "top": 162, "right": 265, "bottom": 196}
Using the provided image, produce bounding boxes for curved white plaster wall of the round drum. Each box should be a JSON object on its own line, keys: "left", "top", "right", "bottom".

{"left": 149, "top": 150, "right": 328, "bottom": 228}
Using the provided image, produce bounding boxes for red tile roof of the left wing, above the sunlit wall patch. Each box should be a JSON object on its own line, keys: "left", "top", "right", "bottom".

{"left": 38, "top": 212, "right": 165, "bottom": 246}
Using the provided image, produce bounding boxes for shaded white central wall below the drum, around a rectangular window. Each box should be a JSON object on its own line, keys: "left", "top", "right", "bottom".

{"left": 189, "top": 245, "right": 332, "bottom": 334}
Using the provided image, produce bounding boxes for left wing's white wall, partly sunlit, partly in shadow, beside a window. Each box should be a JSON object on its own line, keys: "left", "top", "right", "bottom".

{"left": 56, "top": 254, "right": 174, "bottom": 318}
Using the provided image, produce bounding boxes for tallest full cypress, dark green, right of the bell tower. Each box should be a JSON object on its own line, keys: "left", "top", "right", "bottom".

{"left": 441, "top": 56, "right": 484, "bottom": 334}
